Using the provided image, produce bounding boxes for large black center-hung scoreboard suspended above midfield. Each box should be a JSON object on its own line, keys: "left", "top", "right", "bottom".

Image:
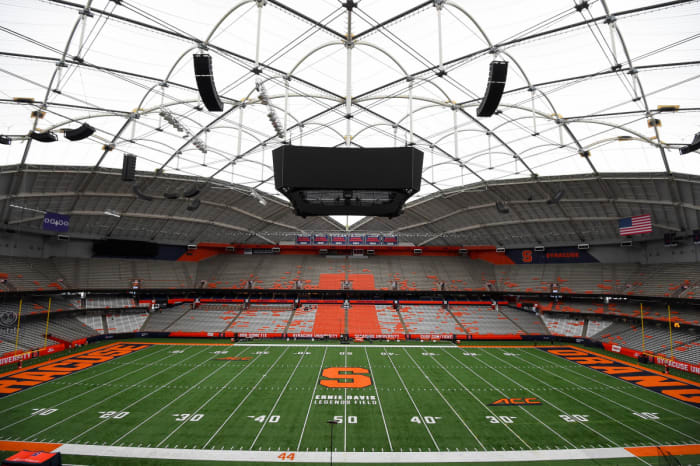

{"left": 272, "top": 145, "right": 423, "bottom": 218}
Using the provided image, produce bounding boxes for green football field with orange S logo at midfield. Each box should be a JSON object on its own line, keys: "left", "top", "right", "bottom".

{"left": 0, "top": 342, "right": 700, "bottom": 463}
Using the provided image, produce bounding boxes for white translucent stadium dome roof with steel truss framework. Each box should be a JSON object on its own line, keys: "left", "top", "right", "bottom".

{"left": 0, "top": 0, "right": 700, "bottom": 248}
